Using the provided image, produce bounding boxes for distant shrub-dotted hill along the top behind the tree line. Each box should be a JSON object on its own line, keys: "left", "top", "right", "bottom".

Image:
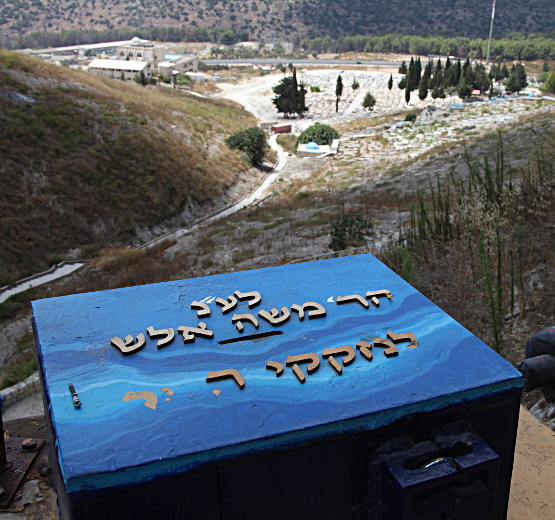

{"left": 0, "top": 0, "right": 555, "bottom": 45}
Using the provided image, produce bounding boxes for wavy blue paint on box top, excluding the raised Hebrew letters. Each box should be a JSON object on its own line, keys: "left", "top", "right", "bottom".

{"left": 33, "top": 255, "right": 522, "bottom": 492}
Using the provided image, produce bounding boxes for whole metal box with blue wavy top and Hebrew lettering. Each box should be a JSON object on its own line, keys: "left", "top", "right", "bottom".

{"left": 32, "top": 255, "right": 523, "bottom": 520}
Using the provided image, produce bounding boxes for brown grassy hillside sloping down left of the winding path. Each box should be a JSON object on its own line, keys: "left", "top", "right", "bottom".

{"left": 0, "top": 51, "right": 254, "bottom": 286}
